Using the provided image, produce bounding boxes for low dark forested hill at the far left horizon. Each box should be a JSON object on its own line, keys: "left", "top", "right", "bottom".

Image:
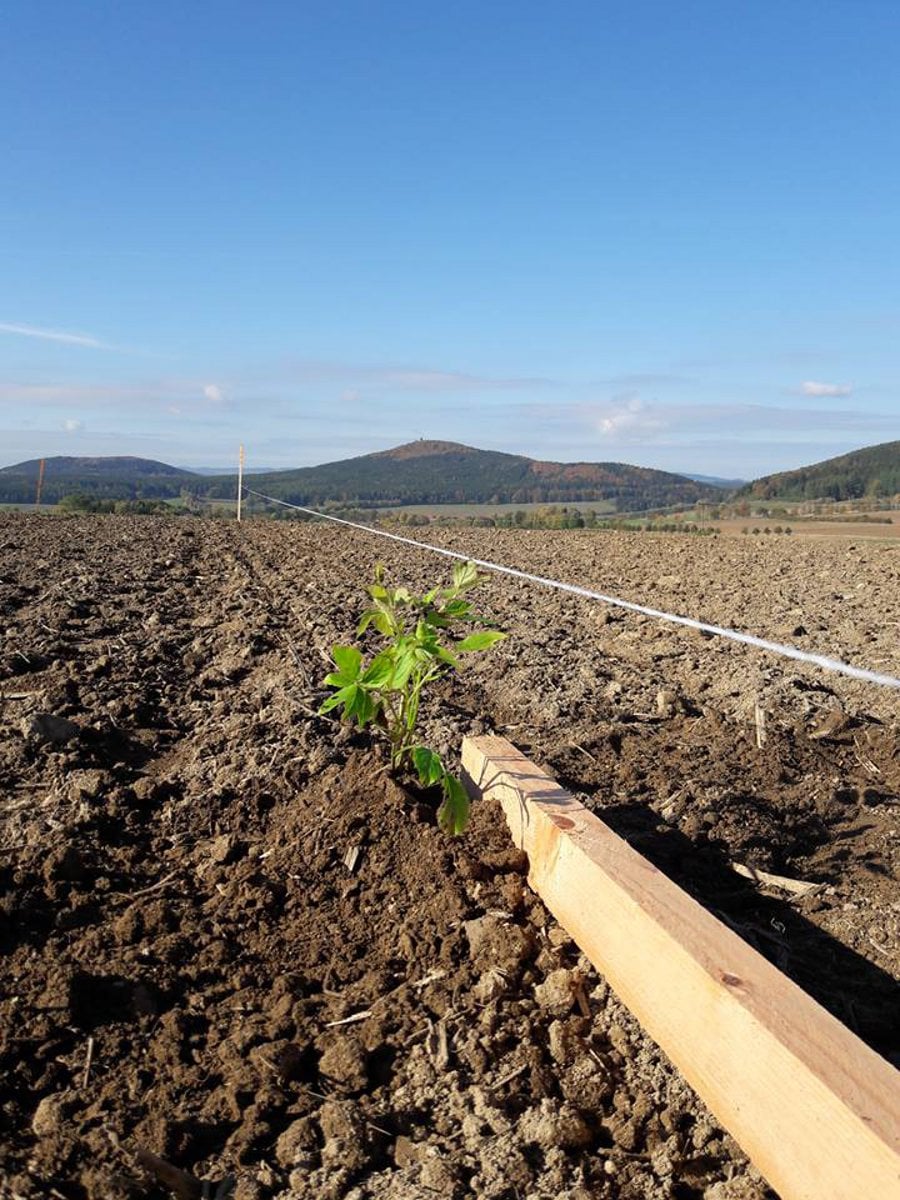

{"left": 0, "top": 456, "right": 199, "bottom": 504}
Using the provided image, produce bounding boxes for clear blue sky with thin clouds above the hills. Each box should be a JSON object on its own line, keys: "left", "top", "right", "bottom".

{"left": 0, "top": 0, "right": 900, "bottom": 478}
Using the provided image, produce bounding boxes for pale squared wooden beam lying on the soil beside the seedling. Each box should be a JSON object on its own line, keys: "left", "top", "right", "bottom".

{"left": 462, "top": 737, "right": 900, "bottom": 1200}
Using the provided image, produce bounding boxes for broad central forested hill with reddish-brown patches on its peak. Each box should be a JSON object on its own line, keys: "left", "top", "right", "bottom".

{"left": 198, "top": 440, "right": 724, "bottom": 511}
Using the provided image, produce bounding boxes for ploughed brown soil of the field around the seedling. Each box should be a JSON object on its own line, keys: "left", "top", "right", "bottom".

{"left": 0, "top": 515, "right": 900, "bottom": 1200}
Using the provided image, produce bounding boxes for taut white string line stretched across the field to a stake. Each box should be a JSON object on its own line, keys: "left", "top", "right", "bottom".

{"left": 245, "top": 487, "right": 900, "bottom": 689}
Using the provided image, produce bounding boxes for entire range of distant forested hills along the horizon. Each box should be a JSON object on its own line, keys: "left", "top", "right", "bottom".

{"left": 0, "top": 439, "right": 900, "bottom": 512}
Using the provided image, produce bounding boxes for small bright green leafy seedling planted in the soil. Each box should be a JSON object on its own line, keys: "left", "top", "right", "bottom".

{"left": 319, "top": 563, "right": 506, "bottom": 834}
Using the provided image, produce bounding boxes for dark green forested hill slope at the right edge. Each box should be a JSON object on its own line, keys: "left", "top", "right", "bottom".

{"left": 738, "top": 442, "right": 900, "bottom": 500}
